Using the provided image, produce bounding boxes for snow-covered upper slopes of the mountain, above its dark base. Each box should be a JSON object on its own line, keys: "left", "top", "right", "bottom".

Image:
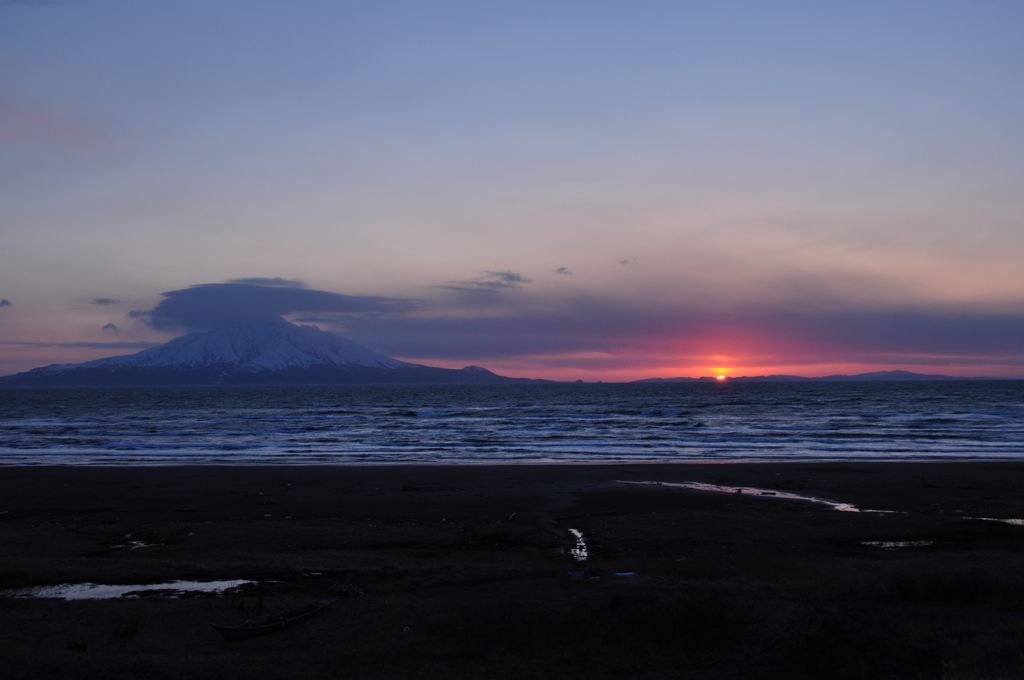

{"left": 56, "top": 318, "right": 417, "bottom": 373}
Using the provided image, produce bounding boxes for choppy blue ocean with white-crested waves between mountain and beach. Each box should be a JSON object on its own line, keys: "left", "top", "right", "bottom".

{"left": 0, "top": 380, "right": 1024, "bottom": 465}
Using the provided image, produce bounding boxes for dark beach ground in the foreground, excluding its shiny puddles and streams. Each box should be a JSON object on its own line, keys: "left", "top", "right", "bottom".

{"left": 0, "top": 463, "right": 1024, "bottom": 680}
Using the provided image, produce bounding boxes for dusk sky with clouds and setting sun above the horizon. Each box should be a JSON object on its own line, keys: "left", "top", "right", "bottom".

{"left": 0, "top": 0, "right": 1024, "bottom": 381}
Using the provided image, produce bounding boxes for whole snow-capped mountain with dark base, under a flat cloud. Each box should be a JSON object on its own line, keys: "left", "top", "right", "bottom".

{"left": 0, "top": 317, "right": 528, "bottom": 386}
